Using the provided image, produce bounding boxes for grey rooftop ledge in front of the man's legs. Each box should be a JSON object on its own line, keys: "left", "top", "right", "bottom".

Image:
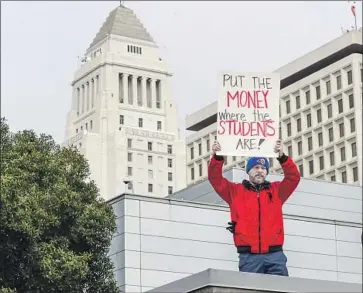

{"left": 147, "top": 269, "right": 362, "bottom": 293}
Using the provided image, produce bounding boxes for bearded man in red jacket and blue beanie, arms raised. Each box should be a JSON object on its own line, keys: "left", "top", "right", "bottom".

{"left": 208, "top": 141, "right": 300, "bottom": 276}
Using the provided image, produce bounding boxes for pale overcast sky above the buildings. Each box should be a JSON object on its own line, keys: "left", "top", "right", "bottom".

{"left": 1, "top": 1, "right": 362, "bottom": 142}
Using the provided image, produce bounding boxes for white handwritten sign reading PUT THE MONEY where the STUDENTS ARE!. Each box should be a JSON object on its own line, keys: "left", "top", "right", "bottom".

{"left": 217, "top": 72, "right": 280, "bottom": 157}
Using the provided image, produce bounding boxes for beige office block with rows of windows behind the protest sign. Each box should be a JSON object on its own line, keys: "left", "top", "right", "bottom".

{"left": 186, "top": 30, "right": 363, "bottom": 185}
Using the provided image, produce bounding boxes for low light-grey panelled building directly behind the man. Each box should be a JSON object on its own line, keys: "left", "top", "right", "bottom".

{"left": 109, "top": 168, "right": 362, "bottom": 292}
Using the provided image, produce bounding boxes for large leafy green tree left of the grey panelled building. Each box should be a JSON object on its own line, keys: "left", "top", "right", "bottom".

{"left": 0, "top": 118, "right": 119, "bottom": 293}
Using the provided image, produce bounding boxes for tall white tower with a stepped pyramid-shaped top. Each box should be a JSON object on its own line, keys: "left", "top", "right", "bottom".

{"left": 65, "top": 5, "right": 186, "bottom": 200}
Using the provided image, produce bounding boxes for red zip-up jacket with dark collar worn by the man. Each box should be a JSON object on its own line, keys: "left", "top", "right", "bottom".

{"left": 208, "top": 155, "right": 300, "bottom": 253}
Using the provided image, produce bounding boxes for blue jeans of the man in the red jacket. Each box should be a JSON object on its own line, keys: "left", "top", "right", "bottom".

{"left": 238, "top": 251, "right": 289, "bottom": 276}
